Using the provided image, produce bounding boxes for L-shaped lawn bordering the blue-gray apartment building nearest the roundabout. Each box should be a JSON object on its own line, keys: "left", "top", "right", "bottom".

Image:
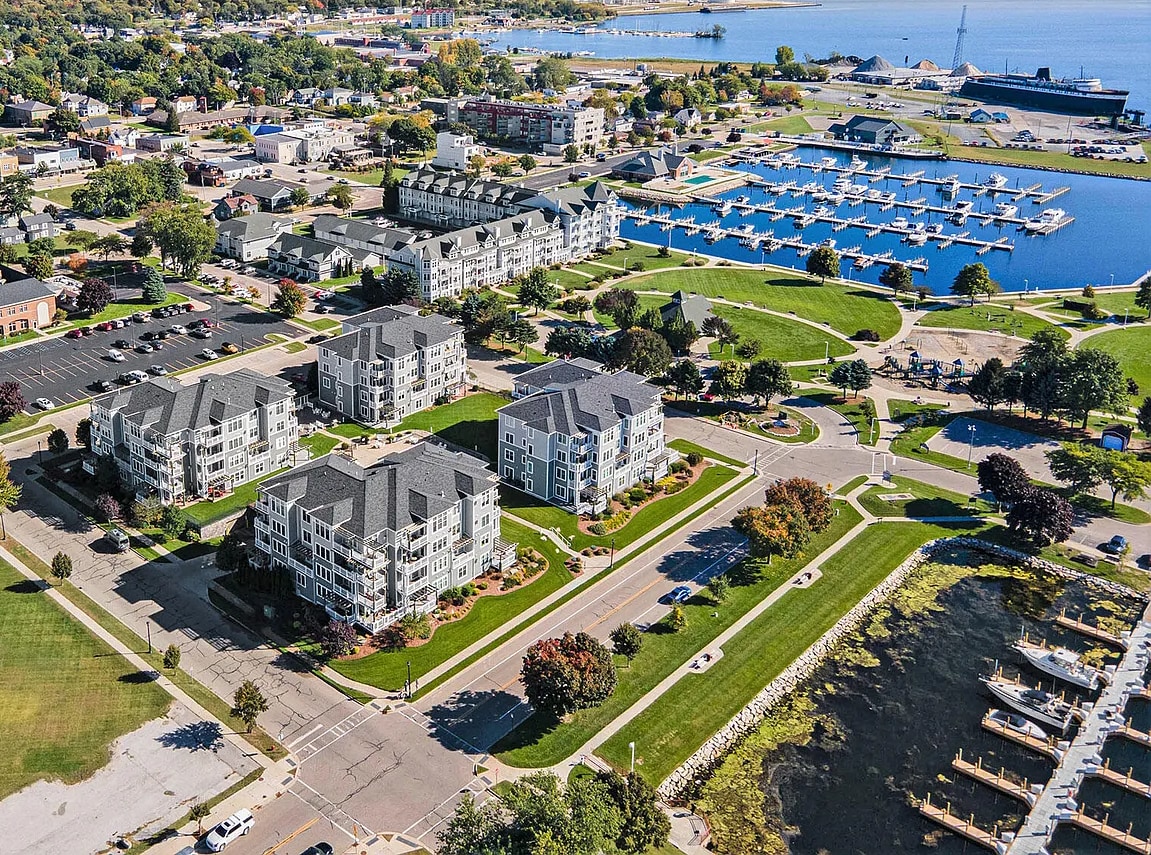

{"left": 500, "top": 466, "right": 738, "bottom": 550}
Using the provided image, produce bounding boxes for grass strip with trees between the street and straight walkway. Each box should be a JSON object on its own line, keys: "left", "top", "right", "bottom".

{"left": 493, "top": 505, "right": 860, "bottom": 768}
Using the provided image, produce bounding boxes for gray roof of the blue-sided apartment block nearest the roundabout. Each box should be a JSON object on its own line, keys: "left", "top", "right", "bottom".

{"left": 498, "top": 371, "right": 660, "bottom": 436}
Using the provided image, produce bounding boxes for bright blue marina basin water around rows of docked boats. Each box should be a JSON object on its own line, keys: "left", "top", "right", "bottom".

{"left": 622, "top": 148, "right": 1151, "bottom": 293}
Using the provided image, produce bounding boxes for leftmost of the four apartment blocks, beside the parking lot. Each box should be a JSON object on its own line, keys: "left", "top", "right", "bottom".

{"left": 91, "top": 368, "right": 299, "bottom": 504}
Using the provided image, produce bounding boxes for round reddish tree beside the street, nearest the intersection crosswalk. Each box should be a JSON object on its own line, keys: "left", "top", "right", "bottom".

{"left": 520, "top": 633, "right": 616, "bottom": 718}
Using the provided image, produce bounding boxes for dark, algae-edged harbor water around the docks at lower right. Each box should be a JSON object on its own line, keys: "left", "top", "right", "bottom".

{"left": 701, "top": 552, "right": 1151, "bottom": 855}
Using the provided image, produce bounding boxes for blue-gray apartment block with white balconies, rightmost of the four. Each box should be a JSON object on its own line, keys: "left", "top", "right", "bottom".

{"left": 497, "top": 360, "right": 676, "bottom": 513}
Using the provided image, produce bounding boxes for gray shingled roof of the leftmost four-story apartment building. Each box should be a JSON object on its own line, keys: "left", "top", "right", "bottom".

{"left": 94, "top": 368, "right": 295, "bottom": 436}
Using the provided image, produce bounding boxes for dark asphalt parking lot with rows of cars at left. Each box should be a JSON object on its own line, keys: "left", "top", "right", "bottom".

{"left": 0, "top": 293, "right": 300, "bottom": 406}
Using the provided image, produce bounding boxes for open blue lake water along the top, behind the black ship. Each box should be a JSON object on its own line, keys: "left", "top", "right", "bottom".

{"left": 496, "top": 0, "right": 1151, "bottom": 108}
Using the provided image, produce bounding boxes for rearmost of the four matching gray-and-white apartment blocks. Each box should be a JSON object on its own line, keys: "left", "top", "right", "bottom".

{"left": 318, "top": 306, "right": 467, "bottom": 427}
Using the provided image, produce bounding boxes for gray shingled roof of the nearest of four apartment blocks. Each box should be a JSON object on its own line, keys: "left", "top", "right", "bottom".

{"left": 259, "top": 442, "right": 496, "bottom": 539}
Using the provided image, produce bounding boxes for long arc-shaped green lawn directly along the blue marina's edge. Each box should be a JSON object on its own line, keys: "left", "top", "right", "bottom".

{"left": 627, "top": 267, "right": 900, "bottom": 345}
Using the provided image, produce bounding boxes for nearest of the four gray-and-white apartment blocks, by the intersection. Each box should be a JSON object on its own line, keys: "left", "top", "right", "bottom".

{"left": 256, "top": 442, "right": 514, "bottom": 633}
